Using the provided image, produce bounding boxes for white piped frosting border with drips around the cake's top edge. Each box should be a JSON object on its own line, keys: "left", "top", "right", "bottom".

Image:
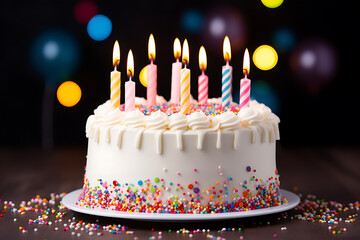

{"left": 86, "top": 96, "right": 280, "bottom": 154}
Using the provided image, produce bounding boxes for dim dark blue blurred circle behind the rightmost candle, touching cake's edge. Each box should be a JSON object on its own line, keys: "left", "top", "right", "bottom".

{"left": 250, "top": 80, "right": 281, "bottom": 114}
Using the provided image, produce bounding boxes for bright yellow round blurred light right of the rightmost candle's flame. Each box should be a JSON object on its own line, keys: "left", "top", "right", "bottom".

{"left": 253, "top": 45, "right": 278, "bottom": 71}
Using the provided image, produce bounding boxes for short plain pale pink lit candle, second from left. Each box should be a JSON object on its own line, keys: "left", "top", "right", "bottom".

{"left": 125, "top": 49, "right": 135, "bottom": 112}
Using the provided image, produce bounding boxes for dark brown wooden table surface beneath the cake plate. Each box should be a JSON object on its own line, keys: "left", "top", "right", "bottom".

{"left": 0, "top": 146, "right": 360, "bottom": 240}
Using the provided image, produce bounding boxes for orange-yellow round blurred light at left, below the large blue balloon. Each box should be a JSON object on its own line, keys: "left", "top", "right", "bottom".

{"left": 56, "top": 81, "right": 81, "bottom": 107}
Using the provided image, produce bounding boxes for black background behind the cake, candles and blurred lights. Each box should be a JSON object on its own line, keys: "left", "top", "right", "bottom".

{"left": 0, "top": 0, "right": 360, "bottom": 147}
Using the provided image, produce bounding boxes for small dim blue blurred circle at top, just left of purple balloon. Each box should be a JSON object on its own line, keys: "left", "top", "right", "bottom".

{"left": 180, "top": 9, "right": 204, "bottom": 33}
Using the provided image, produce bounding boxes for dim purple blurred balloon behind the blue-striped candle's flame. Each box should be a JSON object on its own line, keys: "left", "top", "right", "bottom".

{"left": 202, "top": 6, "right": 246, "bottom": 53}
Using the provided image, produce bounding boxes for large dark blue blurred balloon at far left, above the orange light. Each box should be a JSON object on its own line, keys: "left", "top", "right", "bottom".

{"left": 30, "top": 29, "right": 80, "bottom": 85}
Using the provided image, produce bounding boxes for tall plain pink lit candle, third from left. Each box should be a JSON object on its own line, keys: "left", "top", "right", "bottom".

{"left": 146, "top": 34, "right": 157, "bottom": 107}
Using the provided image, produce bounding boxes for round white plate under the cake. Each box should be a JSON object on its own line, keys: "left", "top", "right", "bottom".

{"left": 61, "top": 189, "right": 300, "bottom": 222}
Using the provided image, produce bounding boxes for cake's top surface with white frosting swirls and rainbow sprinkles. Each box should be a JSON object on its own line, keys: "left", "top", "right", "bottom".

{"left": 87, "top": 97, "right": 280, "bottom": 131}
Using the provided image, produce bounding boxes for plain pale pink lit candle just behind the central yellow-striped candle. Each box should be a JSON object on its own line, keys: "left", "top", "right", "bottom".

{"left": 170, "top": 38, "right": 181, "bottom": 104}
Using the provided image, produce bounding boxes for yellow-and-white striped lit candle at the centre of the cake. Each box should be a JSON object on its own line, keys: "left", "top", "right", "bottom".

{"left": 180, "top": 39, "right": 190, "bottom": 114}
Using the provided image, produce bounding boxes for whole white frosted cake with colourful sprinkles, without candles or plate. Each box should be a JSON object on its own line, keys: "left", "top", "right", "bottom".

{"left": 77, "top": 99, "right": 286, "bottom": 214}
